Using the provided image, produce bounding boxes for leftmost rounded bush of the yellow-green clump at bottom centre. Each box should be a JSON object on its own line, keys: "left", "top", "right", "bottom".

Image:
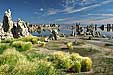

{"left": 49, "top": 51, "right": 72, "bottom": 69}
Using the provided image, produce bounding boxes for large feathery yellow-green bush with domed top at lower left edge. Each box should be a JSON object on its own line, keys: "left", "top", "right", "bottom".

{"left": 0, "top": 48, "right": 26, "bottom": 66}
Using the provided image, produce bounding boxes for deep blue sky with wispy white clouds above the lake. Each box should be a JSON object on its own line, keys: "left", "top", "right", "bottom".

{"left": 0, "top": 0, "right": 113, "bottom": 24}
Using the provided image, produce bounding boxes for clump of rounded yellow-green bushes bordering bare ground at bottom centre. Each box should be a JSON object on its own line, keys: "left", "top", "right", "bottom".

{"left": 49, "top": 51, "right": 92, "bottom": 73}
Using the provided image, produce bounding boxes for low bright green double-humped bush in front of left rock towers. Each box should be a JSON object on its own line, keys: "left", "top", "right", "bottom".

{"left": 12, "top": 41, "right": 33, "bottom": 51}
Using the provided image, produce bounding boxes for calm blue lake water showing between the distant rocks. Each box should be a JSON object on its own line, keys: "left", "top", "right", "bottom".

{"left": 32, "top": 25, "right": 113, "bottom": 37}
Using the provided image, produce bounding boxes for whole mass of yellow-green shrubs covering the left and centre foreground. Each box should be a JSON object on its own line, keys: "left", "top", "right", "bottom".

{"left": 0, "top": 36, "right": 92, "bottom": 75}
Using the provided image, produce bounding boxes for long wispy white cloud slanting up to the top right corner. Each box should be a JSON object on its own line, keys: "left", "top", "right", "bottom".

{"left": 47, "top": 0, "right": 113, "bottom": 15}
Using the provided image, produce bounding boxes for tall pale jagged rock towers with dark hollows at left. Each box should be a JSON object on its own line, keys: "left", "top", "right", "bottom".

{"left": 0, "top": 9, "right": 30, "bottom": 39}
